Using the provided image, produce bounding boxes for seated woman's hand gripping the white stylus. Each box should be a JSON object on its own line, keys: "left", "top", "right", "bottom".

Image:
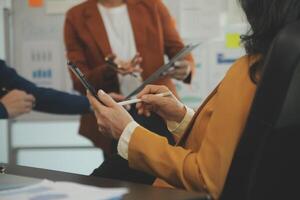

{"left": 136, "top": 85, "right": 186, "bottom": 123}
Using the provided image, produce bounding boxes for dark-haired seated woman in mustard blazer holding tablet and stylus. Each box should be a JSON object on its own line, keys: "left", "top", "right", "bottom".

{"left": 89, "top": 0, "right": 300, "bottom": 199}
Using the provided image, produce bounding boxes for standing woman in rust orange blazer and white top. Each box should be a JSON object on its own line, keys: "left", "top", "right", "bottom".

{"left": 64, "top": 0, "right": 194, "bottom": 154}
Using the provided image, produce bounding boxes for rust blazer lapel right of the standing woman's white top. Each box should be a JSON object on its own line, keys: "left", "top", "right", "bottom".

{"left": 126, "top": 0, "right": 146, "bottom": 56}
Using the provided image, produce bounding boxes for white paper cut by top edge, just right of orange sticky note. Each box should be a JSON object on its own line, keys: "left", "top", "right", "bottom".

{"left": 46, "top": 0, "right": 84, "bottom": 15}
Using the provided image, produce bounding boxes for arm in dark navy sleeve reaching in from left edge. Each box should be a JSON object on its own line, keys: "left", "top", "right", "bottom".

{"left": 1, "top": 60, "right": 90, "bottom": 114}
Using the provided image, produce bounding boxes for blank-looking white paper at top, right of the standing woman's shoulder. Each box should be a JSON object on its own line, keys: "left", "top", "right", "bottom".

{"left": 180, "top": 0, "right": 222, "bottom": 40}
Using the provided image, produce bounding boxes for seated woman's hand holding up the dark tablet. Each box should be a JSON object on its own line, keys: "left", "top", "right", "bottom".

{"left": 87, "top": 90, "right": 133, "bottom": 139}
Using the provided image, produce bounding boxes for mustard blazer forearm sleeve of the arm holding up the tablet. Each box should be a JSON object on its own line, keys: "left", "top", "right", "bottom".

{"left": 128, "top": 127, "right": 205, "bottom": 190}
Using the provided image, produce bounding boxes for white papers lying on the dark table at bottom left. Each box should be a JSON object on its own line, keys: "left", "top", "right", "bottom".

{"left": 0, "top": 180, "right": 128, "bottom": 200}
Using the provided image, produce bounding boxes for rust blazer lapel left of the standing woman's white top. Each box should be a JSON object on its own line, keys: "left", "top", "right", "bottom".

{"left": 85, "top": 0, "right": 112, "bottom": 56}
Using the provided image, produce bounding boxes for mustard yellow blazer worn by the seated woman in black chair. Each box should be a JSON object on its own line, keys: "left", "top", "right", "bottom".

{"left": 128, "top": 57, "right": 256, "bottom": 199}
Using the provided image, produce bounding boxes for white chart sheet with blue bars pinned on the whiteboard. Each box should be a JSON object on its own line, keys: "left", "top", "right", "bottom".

{"left": 21, "top": 40, "right": 63, "bottom": 89}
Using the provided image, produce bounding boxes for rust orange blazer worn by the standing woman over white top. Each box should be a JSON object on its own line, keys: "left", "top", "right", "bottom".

{"left": 64, "top": 0, "right": 193, "bottom": 153}
